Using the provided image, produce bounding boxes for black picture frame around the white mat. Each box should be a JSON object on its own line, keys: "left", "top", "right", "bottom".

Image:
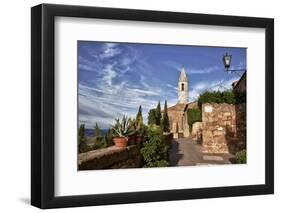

{"left": 31, "top": 4, "right": 274, "bottom": 209}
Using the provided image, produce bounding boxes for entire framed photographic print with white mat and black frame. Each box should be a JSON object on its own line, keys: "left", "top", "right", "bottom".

{"left": 31, "top": 4, "right": 274, "bottom": 208}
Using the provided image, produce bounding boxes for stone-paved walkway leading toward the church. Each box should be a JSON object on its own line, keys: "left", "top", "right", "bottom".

{"left": 169, "top": 138, "right": 235, "bottom": 166}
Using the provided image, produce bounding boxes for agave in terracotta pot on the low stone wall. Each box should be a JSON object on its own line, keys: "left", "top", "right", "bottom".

{"left": 112, "top": 116, "right": 135, "bottom": 147}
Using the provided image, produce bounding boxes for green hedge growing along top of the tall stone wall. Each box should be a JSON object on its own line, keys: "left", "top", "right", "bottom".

{"left": 198, "top": 91, "right": 246, "bottom": 107}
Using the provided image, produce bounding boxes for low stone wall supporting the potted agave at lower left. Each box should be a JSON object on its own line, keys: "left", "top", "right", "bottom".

{"left": 78, "top": 145, "right": 141, "bottom": 170}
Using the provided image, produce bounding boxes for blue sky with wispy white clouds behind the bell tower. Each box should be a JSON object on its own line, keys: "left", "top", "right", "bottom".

{"left": 78, "top": 41, "right": 246, "bottom": 129}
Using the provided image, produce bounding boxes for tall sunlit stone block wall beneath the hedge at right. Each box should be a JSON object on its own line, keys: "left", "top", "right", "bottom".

{"left": 202, "top": 103, "right": 246, "bottom": 153}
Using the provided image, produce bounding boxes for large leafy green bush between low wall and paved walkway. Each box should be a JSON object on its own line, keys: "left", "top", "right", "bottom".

{"left": 141, "top": 126, "right": 169, "bottom": 167}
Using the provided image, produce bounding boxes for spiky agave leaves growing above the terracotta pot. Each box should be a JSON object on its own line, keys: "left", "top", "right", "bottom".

{"left": 112, "top": 116, "right": 135, "bottom": 137}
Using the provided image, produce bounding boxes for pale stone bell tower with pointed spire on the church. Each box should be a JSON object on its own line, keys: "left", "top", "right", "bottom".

{"left": 178, "top": 67, "right": 188, "bottom": 104}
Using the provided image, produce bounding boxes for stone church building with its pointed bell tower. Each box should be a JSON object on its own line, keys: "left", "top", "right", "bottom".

{"left": 168, "top": 67, "right": 197, "bottom": 138}
